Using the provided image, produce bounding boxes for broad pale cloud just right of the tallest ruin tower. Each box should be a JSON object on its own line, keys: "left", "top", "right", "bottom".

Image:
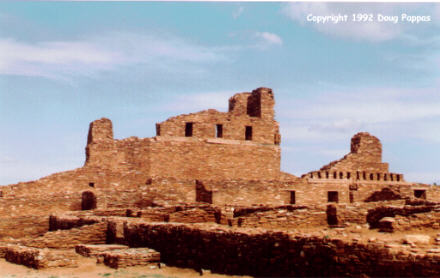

{"left": 278, "top": 88, "right": 440, "bottom": 142}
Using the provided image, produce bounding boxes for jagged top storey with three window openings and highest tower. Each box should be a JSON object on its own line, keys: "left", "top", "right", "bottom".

{"left": 156, "top": 88, "right": 281, "bottom": 145}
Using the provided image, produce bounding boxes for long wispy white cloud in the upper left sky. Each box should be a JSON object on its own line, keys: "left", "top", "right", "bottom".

{"left": 0, "top": 33, "right": 227, "bottom": 79}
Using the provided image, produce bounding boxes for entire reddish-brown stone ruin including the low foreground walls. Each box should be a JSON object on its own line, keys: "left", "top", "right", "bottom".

{"left": 0, "top": 88, "right": 440, "bottom": 276}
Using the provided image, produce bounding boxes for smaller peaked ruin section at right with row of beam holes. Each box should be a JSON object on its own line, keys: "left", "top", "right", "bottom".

{"left": 289, "top": 132, "right": 428, "bottom": 205}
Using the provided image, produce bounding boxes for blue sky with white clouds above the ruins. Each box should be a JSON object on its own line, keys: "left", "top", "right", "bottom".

{"left": 0, "top": 2, "right": 440, "bottom": 184}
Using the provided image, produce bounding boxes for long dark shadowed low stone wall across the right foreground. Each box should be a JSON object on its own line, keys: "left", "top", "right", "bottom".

{"left": 124, "top": 222, "right": 440, "bottom": 277}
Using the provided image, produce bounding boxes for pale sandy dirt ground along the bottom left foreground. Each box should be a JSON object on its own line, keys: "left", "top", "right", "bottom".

{"left": 0, "top": 258, "right": 246, "bottom": 278}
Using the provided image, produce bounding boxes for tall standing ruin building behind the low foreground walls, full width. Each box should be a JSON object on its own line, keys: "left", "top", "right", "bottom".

{"left": 0, "top": 88, "right": 439, "bottom": 219}
